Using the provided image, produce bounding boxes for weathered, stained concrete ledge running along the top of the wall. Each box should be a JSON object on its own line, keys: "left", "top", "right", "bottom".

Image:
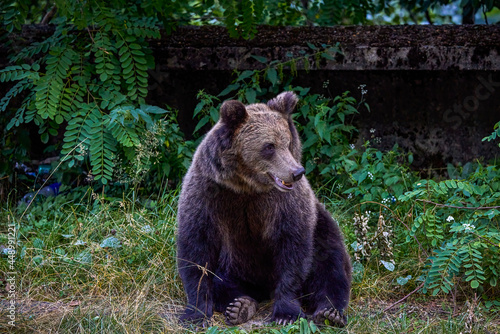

{"left": 155, "top": 25, "right": 500, "bottom": 71}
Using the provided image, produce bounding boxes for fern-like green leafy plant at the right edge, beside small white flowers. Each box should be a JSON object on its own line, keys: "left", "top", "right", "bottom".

{"left": 399, "top": 165, "right": 500, "bottom": 294}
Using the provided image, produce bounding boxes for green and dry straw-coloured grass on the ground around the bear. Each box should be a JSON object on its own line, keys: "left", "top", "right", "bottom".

{"left": 0, "top": 192, "right": 500, "bottom": 333}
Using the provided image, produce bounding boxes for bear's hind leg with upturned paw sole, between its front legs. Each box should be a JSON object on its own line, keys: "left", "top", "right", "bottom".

{"left": 214, "top": 273, "right": 258, "bottom": 326}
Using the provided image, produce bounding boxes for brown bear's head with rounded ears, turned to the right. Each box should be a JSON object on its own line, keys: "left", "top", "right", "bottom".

{"left": 216, "top": 92, "right": 305, "bottom": 192}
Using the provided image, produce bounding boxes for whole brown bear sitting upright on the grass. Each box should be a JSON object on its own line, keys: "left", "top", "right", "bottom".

{"left": 177, "top": 92, "right": 351, "bottom": 326}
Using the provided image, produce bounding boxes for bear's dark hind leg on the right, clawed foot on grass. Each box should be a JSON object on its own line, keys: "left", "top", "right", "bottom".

{"left": 303, "top": 204, "right": 351, "bottom": 327}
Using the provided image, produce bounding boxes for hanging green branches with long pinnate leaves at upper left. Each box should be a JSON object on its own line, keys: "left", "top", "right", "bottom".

{"left": 0, "top": 1, "right": 198, "bottom": 184}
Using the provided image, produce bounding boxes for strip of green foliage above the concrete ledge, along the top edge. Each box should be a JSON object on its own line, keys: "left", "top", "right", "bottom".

{"left": 4, "top": 0, "right": 500, "bottom": 44}
